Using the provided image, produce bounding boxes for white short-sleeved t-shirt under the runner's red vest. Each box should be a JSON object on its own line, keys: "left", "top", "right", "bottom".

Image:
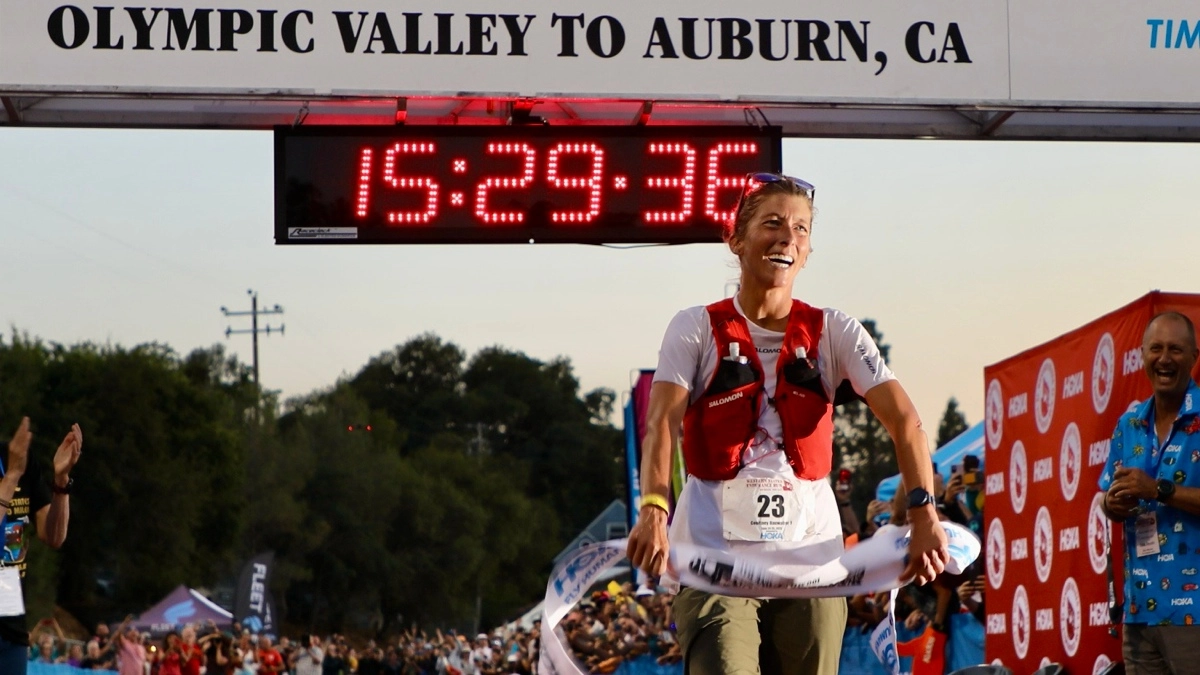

{"left": 654, "top": 299, "right": 895, "bottom": 554}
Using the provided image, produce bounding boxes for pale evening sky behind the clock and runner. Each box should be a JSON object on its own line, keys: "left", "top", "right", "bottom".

{"left": 0, "top": 127, "right": 1200, "bottom": 435}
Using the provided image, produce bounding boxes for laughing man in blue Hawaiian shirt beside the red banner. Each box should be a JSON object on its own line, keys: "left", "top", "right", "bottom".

{"left": 1099, "top": 312, "right": 1200, "bottom": 675}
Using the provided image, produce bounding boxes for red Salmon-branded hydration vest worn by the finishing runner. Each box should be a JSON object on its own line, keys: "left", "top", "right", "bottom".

{"left": 683, "top": 298, "right": 833, "bottom": 480}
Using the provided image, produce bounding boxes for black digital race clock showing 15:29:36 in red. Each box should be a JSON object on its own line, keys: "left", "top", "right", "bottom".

{"left": 275, "top": 126, "right": 781, "bottom": 244}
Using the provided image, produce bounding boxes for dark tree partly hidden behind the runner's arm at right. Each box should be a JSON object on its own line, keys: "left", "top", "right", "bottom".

{"left": 833, "top": 318, "right": 900, "bottom": 514}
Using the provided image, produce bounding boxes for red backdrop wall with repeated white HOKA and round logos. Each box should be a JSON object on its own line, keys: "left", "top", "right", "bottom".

{"left": 984, "top": 292, "right": 1200, "bottom": 673}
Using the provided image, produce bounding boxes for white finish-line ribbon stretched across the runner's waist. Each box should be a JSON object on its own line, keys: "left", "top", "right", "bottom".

{"left": 539, "top": 522, "right": 982, "bottom": 675}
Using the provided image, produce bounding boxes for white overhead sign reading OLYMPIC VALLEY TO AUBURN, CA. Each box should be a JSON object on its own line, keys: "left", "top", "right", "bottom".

{"left": 0, "top": 0, "right": 1200, "bottom": 106}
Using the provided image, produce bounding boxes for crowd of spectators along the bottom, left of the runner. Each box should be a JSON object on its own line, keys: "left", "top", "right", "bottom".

{"left": 21, "top": 584, "right": 682, "bottom": 675}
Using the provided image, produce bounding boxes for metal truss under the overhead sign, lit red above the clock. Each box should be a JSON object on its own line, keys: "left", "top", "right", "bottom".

{"left": 7, "top": 90, "right": 1200, "bottom": 142}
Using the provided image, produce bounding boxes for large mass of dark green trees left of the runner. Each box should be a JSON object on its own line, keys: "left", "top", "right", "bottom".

{"left": 0, "top": 334, "right": 623, "bottom": 633}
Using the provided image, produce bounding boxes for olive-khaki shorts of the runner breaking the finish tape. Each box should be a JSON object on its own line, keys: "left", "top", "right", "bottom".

{"left": 672, "top": 589, "right": 847, "bottom": 675}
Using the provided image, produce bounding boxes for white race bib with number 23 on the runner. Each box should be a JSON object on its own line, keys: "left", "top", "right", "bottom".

{"left": 721, "top": 476, "right": 808, "bottom": 542}
